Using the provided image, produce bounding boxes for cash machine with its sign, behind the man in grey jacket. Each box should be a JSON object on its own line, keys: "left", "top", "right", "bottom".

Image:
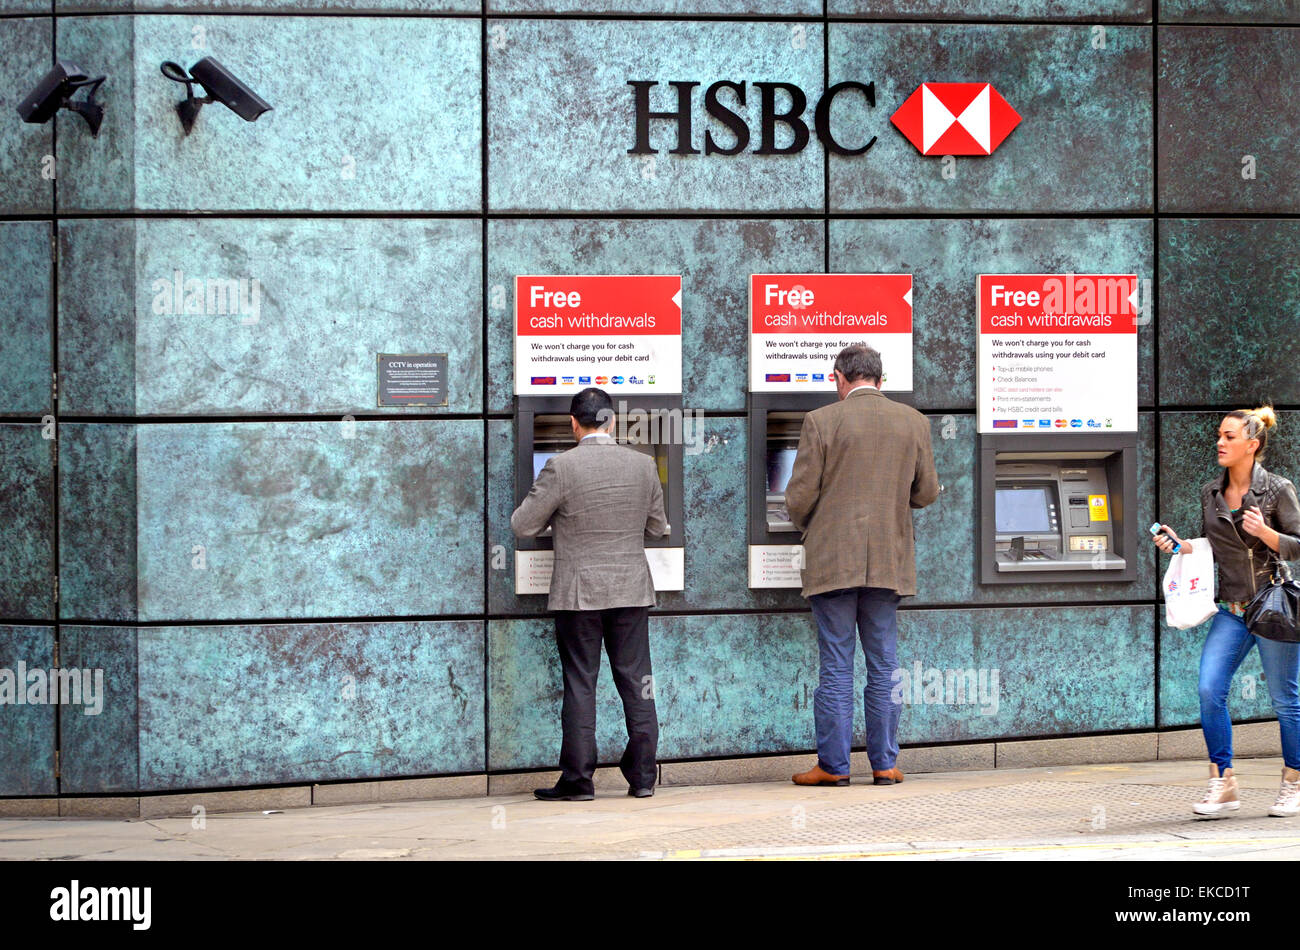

{"left": 515, "top": 274, "right": 685, "bottom": 594}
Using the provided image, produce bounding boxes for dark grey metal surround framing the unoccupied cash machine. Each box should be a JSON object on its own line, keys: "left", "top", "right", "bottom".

{"left": 975, "top": 433, "right": 1138, "bottom": 584}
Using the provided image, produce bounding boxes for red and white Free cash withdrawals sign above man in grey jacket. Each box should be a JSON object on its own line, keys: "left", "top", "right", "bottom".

{"left": 515, "top": 274, "right": 681, "bottom": 396}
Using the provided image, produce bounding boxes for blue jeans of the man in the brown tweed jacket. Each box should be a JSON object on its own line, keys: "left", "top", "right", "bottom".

{"left": 809, "top": 587, "right": 902, "bottom": 775}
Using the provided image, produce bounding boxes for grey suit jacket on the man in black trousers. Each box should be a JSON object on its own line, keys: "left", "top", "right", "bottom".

{"left": 510, "top": 435, "right": 668, "bottom": 611}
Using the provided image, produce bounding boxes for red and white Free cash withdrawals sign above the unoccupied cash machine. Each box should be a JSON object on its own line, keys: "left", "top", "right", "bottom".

{"left": 976, "top": 274, "right": 1139, "bottom": 433}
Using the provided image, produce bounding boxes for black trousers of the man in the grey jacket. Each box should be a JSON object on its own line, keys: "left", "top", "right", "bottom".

{"left": 555, "top": 607, "right": 659, "bottom": 794}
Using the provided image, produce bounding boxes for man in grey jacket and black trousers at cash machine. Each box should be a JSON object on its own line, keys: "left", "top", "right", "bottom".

{"left": 510, "top": 389, "right": 668, "bottom": 802}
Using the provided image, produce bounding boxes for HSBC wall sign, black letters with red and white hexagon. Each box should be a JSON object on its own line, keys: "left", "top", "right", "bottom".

{"left": 628, "top": 79, "right": 1021, "bottom": 155}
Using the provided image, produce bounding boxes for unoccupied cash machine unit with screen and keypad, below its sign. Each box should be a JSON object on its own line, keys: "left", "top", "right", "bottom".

{"left": 979, "top": 433, "right": 1138, "bottom": 584}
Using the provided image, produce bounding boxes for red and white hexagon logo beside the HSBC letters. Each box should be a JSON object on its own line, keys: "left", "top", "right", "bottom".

{"left": 889, "top": 82, "right": 1021, "bottom": 155}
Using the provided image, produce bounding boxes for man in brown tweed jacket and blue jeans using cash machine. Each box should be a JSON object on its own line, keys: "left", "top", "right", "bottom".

{"left": 785, "top": 346, "right": 940, "bottom": 785}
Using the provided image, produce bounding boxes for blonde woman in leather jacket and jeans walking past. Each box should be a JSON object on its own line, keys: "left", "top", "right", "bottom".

{"left": 1154, "top": 407, "right": 1300, "bottom": 817}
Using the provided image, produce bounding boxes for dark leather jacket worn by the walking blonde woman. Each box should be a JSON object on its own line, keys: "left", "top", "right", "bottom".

{"left": 1201, "top": 463, "right": 1300, "bottom": 602}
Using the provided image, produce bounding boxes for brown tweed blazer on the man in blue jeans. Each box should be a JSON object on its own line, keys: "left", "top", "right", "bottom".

{"left": 785, "top": 386, "right": 939, "bottom": 597}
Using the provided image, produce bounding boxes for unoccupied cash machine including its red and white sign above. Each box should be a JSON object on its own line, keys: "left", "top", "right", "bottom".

{"left": 976, "top": 274, "right": 1140, "bottom": 585}
